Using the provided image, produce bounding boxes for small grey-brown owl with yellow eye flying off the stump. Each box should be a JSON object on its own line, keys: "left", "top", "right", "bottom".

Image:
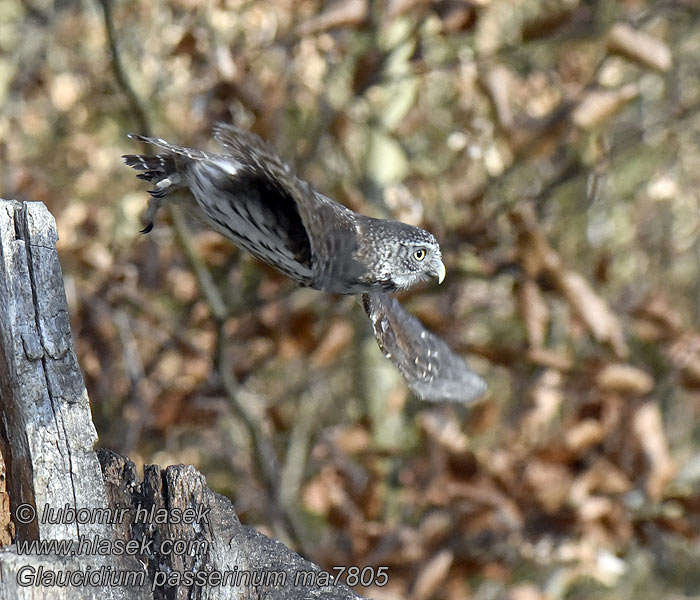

{"left": 123, "top": 123, "right": 486, "bottom": 403}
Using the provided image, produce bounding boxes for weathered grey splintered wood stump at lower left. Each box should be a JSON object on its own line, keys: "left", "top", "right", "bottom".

{"left": 0, "top": 200, "right": 359, "bottom": 600}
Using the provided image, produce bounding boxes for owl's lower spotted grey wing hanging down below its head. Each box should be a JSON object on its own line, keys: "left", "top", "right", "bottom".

{"left": 362, "top": 293, "right": 486, "bottom": 404}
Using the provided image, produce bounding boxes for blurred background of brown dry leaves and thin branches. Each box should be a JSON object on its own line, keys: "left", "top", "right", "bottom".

{"left": 0, "top": 0, "right": 700, "bottom": 600}
